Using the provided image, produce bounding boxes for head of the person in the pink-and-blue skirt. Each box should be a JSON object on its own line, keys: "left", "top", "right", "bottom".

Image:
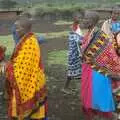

{"left": 83, "top": 11, "right": 99, "bottom": 29}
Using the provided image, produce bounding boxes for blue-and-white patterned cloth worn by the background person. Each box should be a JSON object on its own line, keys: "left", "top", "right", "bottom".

{"left": 68, "top": 32, "right": 83, "bottom": 77}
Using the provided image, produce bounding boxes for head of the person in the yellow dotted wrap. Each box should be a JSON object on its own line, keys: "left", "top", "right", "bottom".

{"left": 15, "top": 18, "right": 32, "bottom": 38}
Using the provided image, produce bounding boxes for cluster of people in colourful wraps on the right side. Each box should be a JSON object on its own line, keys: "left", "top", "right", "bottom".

{"left": 64, "top": 8, "right": 120, "bottom": 120}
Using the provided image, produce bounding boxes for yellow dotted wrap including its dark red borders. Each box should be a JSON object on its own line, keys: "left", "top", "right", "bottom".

{"left": 6, "top": 34, "right": 47, "bottom": 120}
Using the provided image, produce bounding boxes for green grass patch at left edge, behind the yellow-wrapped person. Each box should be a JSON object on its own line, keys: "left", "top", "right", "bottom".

{"left": 0, "top": 35, "right": 14, "bottom": 57}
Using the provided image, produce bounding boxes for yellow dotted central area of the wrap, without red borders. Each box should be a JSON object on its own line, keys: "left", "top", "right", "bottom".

{"left": 13, "top": 35, "right": 45, "bottom": 103}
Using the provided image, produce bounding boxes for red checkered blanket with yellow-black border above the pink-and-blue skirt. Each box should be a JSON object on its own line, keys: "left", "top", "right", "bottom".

{"left": 83, "top": 31, "right": 120, "bottom": 75}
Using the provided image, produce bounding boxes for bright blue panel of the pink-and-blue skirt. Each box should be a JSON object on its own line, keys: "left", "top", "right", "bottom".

{"left": 92, "top": 71, "right": 115, "bottom": 112}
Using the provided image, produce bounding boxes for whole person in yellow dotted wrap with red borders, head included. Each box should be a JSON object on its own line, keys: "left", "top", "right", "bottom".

{"left": 6, "top": 18, "right": 47, "bottom": 120}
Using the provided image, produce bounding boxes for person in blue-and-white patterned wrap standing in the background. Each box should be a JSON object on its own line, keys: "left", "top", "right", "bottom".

{"left": 63, "top": 17, "right": 83, "bottom": 92}
